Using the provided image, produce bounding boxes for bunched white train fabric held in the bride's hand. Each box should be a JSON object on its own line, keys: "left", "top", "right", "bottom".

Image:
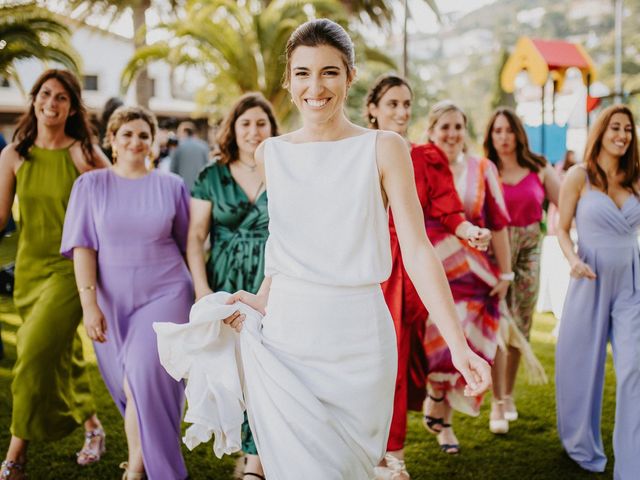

{"left": 153, "top": 292, "right": 262, "bottom": 458}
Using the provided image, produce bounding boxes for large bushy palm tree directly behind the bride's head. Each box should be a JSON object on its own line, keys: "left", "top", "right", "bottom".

{"left": 122, "top": 0, "right": 394, "bottom": 122}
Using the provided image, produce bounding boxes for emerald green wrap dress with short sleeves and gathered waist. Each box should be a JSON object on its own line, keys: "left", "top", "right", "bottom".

{"left": 191, "top": 163, "right": 269, "bottom": 455}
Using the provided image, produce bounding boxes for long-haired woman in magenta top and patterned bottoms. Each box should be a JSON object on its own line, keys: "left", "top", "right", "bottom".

{"left": 483, "top": 107, "right": 560, "bottom": 421}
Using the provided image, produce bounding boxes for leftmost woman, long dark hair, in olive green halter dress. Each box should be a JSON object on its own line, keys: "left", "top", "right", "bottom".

{"left": 0, "top": 70, "right": 108, "bottom": 480}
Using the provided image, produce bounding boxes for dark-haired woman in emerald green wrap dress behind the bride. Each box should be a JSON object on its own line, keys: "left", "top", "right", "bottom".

{"left": 187, "top": 93, "right": 278, "bottom": 479}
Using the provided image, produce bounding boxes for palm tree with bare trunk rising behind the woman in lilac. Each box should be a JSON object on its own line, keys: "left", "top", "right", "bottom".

{"left": 67, "top": 0, "right": 178, "bottom": 108}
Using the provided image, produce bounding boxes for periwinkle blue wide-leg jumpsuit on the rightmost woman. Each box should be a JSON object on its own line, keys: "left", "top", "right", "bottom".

{"left": 556, "top": 172, "right": 640, "bottom": 480}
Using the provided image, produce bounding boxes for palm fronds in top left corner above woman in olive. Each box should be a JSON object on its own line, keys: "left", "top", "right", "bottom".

{"left": 0, "top": 3, "right": 80, "bottom": 95}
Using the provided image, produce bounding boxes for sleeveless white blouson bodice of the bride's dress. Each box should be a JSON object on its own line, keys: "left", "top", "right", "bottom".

{"left": 265, "top": 131, "right": 391, "bottom": 286}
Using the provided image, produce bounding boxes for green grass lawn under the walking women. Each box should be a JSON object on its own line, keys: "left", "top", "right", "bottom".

{"left": 0, "top": 232, "right": 615, "bottom": 480}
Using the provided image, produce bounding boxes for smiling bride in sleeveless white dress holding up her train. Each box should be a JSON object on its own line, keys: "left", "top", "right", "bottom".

{"left": 159, "top": 19, "right": 490, "bottom": 480}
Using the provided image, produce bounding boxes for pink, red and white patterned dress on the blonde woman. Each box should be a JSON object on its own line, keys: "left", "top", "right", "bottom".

{"left": 425, "top": 157, "right": 509, "bottom": 415}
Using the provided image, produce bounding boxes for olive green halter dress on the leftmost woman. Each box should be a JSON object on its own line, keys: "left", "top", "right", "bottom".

{"left": 11, "top": 145, "right": 95, "bottom": 440}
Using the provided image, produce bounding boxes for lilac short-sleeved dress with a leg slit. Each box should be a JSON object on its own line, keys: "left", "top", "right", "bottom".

{"left": 61, "top": 169, "right": 193, "bottom": 479}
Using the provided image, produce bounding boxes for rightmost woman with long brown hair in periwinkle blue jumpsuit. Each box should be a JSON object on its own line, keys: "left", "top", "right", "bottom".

{"left": 556, "top": 105, "right": 640, "bottom": 480}
